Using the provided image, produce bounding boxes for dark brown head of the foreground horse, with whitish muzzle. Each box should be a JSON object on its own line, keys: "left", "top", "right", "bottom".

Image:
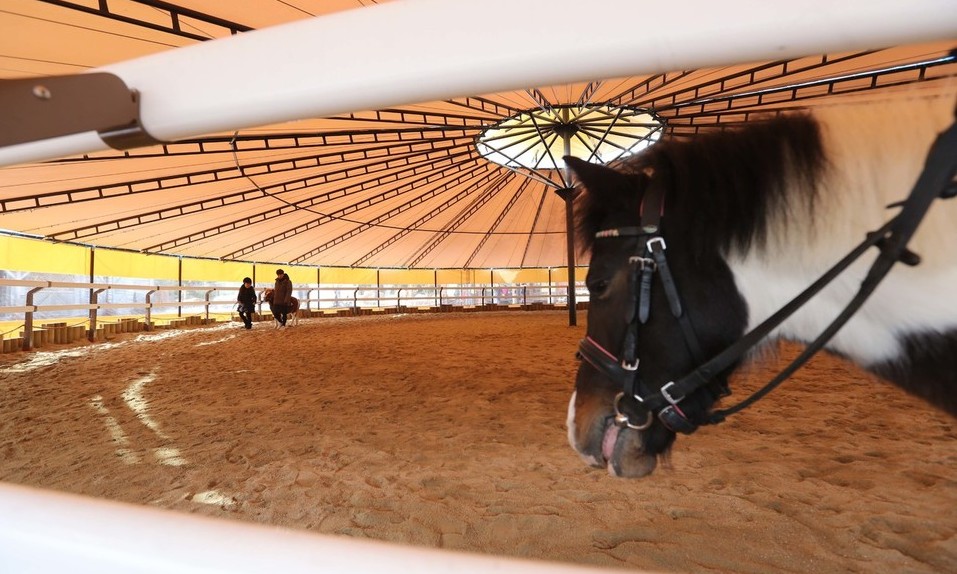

{"left": 566, "top": 154, "right": 747, "bottom": 477}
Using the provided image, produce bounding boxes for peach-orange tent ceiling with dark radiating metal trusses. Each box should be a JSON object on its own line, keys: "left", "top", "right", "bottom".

{"left": 0, "top": 0, "right": 957, "bottom": 268}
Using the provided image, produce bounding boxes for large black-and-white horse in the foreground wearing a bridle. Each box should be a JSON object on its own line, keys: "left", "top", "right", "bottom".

{"left": 565, "top": 94, "right": 957, "bottom": 478}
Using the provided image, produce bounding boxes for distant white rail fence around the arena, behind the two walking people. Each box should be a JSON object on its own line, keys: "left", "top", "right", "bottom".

{"left": 0, "top": 279, "right": 587, "bottom": 352}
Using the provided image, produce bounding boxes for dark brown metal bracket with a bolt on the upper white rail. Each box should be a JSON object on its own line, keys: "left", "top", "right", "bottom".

{"left": 0, "top": 72, "right": 159, "bottom": 150}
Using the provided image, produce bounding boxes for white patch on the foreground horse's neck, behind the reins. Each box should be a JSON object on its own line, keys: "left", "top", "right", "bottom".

{"left": 728, "top": 93, "right": 957, "bottom": 366}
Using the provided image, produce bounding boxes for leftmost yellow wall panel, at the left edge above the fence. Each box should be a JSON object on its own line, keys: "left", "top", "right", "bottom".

{"left": 0, "top": 235, "right": 90, "bottom": 277}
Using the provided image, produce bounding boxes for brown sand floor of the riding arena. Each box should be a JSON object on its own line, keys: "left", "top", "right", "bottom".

{"left": 0, "top": 312, "right": 957, "bottom": 574}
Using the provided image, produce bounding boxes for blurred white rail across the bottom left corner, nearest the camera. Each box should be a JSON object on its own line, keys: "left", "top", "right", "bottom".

{"left": 0, "top": 483, "right": 608, "bottom": 574}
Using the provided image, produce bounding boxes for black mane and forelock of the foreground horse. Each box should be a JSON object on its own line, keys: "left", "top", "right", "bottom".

{"left": 576, "top": 114, "right": 827, "bottom": 253}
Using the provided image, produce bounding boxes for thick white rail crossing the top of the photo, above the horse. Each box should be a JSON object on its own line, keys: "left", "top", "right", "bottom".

{"left": 0, "top": 0, "right": 957, "bottom": 165}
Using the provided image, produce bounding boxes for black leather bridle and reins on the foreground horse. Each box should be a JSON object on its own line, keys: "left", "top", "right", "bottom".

{"left": 578, "top": 109, "right": 957, "bottom": 434}
